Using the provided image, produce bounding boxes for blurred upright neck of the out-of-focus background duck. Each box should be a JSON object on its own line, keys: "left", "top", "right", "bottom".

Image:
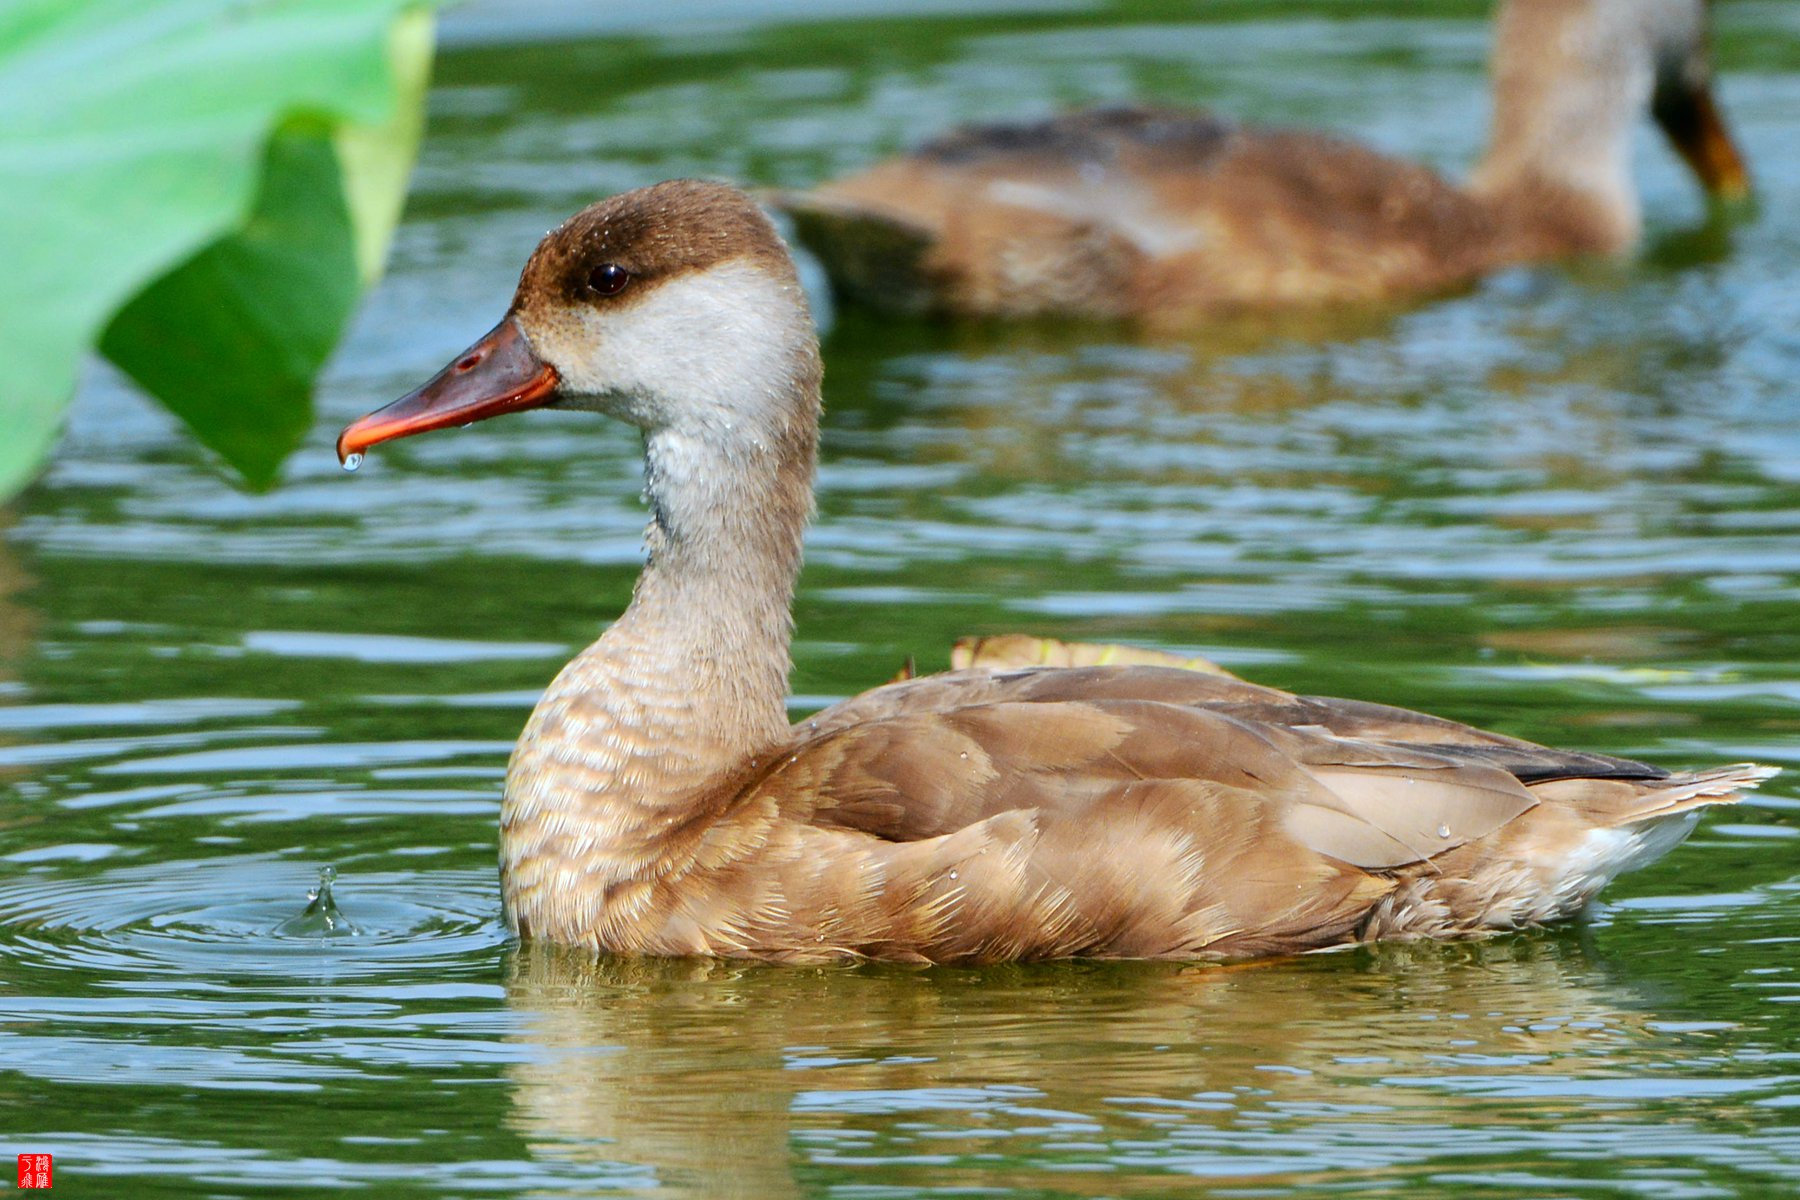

{"left": 1471, "top": 0, "right": 1656, "bottom": 257}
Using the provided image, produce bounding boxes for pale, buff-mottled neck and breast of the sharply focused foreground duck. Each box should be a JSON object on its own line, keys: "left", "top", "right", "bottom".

{"left": 500, "top": 329, "right": 819, "bottom": 910}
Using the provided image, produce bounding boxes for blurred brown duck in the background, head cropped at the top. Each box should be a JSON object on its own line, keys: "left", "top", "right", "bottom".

{"left": 776, "top": 0, "right": 1750, "bottom": 326}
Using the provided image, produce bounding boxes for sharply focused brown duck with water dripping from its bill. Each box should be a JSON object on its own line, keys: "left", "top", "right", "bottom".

{"left": 338, "top": 180, "right": 1773, "bottom": 963}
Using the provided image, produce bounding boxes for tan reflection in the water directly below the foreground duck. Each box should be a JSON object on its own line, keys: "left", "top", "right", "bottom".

{"left": 506, "top": 930, "right": 1679, "bottom": 1196}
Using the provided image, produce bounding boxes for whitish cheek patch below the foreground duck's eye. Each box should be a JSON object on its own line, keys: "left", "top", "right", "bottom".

{"left": 526, "top": 259, "right": 812, "bottom": 426}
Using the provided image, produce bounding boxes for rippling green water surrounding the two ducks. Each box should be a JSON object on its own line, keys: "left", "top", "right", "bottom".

{"left": 0, "top": 0, "right": 1800, "bottom": 1200}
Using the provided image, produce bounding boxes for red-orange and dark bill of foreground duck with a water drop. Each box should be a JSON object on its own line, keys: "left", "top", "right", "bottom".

{"left": 338, "top": 317, "right": 560, "bottom": 466}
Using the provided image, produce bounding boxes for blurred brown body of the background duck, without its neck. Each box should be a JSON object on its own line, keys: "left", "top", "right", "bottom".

{"left": 785, "top": 108, "right": 1505, "bottom": 324}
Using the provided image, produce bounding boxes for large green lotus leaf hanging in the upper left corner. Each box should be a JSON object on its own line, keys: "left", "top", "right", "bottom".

{"left": 0, "top": 0, "right": 430, "bottom": 495}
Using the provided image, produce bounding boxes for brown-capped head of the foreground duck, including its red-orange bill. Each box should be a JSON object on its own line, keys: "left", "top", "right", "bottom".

{"left": 337, "top": 180, "right": 817, "bottom": 462}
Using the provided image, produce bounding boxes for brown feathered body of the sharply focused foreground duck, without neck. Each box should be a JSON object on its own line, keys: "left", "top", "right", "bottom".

{"left": 502, "top": 667, "right": 1766, "bottom": 963}
